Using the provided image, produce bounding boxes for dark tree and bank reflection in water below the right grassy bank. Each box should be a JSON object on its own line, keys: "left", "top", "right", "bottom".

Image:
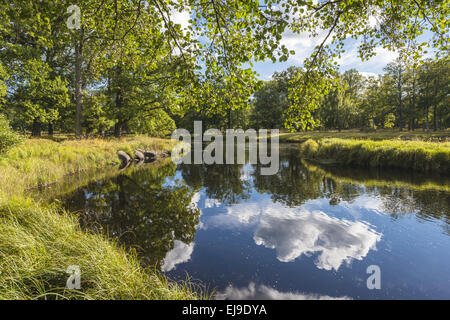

{"left": 253, "top": 150, "right": 450, "bottom": 228}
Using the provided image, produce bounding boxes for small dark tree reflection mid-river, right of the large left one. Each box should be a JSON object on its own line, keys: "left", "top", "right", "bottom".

{"left": 180, "top": 164, "right": 251, "bottom": 204}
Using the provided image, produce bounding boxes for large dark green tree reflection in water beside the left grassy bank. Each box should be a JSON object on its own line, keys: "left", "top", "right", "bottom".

{"left": 63, "top": 162, "right": 200, "bottom": 267}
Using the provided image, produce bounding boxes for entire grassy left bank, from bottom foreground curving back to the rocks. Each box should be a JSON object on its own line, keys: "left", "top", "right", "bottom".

{"left": 0, "top": 137, "right": 198, "bottom": 299}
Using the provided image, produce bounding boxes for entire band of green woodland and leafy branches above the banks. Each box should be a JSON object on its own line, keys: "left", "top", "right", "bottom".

{"left": 0, "top": 1, "right": 450, "bottom": 141}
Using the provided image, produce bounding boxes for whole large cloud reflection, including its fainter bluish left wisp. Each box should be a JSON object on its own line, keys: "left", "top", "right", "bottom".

{"left": 204, "top": 199, "right": 381, "bottom": 270}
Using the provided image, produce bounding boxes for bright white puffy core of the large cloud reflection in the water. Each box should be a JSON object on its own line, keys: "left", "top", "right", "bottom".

{"left": 254, "top": 211, "right": 381, "bottom": 270}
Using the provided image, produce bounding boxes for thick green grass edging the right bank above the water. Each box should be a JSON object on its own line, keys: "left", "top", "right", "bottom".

{"left": 300, "top": 138, "right": 450, "bottom": 173}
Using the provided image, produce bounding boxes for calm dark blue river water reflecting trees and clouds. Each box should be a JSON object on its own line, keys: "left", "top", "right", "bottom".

{"left": 39, "top": 145, "right": 450, "bottom": 299}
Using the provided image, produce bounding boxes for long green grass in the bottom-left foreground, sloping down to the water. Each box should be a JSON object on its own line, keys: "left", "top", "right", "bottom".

{"left": 0, "top": 199, "right": 198, "bottom": 299}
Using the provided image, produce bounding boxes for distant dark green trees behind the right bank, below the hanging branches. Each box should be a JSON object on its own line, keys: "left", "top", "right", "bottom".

{"left": 248, "top": 59, "right": 450, "bottom": 130}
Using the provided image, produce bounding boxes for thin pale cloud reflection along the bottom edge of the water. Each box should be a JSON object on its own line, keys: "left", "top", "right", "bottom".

{"left": 215, "top": 282, "right": 350, "bottom": 300}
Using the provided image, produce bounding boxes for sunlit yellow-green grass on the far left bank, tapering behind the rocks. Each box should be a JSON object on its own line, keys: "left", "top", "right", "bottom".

{"left": 0, "top": 136, "right": 173, "bottom": 195}
